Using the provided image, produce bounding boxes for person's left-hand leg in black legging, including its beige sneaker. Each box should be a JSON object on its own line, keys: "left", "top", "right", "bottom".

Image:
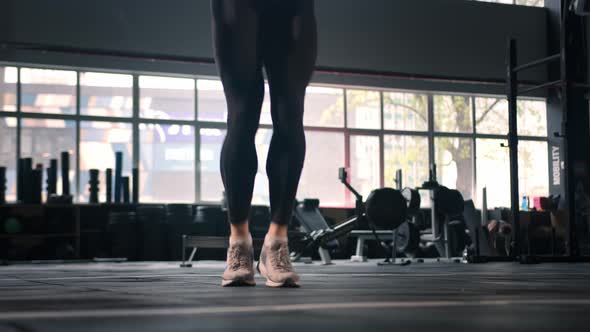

{"left": 211, "top": 0, "right": 264, "bottom": 286}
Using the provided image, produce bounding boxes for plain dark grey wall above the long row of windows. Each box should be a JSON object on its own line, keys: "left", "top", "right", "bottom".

{"left": 0, "top": 0, "right": 547, "bottom": 92}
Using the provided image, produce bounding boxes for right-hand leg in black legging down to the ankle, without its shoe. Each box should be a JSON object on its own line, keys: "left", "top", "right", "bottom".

{"left": 263, "top": 0, "right": 317, "bottom": 235}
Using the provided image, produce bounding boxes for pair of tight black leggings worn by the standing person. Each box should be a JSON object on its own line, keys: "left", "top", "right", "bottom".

{"left": 212, "top": 0, "right": 317, "bottom": 224}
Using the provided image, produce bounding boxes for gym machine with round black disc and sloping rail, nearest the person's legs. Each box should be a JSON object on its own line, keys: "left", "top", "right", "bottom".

{"left": 291, "top": 168, "right": 407, "bottom": 262}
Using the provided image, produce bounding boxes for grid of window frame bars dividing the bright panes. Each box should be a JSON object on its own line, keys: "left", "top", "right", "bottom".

{"left": 0, "top": 62, "right": 550, "bottom": 207}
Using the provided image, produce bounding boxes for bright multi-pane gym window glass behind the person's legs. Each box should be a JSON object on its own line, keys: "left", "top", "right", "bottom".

{"left": 0, "top": 66, "right": 549, "bottom": 207}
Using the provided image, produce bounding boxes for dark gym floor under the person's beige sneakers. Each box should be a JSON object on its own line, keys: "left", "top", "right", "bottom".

{"left": 0, "top": 261, "right": 590, "bottom": 332}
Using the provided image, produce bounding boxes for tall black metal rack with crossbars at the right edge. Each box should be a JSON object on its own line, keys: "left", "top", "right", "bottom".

{"left": 505, "top": 9, "right": 590, "bottom": 262}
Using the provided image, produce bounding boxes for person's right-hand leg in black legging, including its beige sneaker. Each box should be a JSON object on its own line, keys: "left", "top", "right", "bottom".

{"left": 258, "top": 0, "right": 317, "bottom": 287}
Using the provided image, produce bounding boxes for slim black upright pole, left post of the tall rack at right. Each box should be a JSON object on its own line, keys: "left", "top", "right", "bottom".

{"left": 506, "top": 38, "right": 520, "bottom": 256}
